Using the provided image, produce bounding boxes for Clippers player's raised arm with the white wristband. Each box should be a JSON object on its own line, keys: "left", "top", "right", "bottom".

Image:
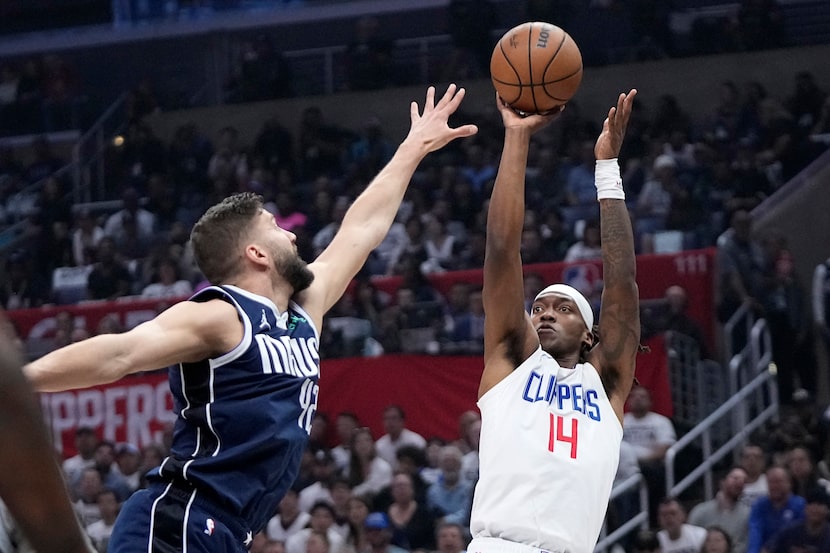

{"left": 590, "top": 89, "right": 640, "bottom": 420}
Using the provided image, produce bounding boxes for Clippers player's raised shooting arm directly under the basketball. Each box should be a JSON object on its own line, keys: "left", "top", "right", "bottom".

{"left": 478, "top": 97, "right": 559, "bottom": 397}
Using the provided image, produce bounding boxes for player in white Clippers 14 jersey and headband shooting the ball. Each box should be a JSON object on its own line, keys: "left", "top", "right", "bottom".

{"left": 467, "top": 90, "right": 640, "bottom": 553}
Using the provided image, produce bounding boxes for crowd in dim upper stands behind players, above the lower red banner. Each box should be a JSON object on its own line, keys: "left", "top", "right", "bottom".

{"left": 0, "top": 63, "right": 830, "bottom": 362}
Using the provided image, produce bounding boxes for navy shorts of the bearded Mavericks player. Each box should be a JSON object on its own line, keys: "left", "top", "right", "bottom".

{"left": 107, "top": 484, "right": 252, "bottom": 553}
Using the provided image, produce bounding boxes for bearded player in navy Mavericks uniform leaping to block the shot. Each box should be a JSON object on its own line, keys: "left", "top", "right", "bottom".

{"left": 26, "top": 85, "right": 477, "bottom": 553}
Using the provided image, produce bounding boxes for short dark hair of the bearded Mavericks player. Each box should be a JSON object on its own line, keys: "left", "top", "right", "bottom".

{"left": 190, "top": 192, "right": 263, "bottom": 284}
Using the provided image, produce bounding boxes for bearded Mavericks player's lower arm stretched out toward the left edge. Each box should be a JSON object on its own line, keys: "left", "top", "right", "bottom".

{"left": 24, "top": 300, "right": 243, "bottom": 392}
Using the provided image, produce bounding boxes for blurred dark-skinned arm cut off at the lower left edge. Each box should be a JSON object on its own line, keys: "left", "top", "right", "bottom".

{"left": 0, "top": 316, "right": 91, "bottom": 553}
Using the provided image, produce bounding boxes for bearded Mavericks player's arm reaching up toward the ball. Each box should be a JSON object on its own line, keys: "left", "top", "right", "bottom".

{"left": 299, "top": 84, "right": 478, "bottom": 324}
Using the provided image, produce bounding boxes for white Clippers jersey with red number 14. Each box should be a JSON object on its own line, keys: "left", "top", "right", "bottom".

{"left": 470, "top": 348, "right": 622, "bottom": 553}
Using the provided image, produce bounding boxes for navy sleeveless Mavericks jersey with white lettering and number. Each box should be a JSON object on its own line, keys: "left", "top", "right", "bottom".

{"left": 150, "top": 286, "right": 320, "bottom": 533}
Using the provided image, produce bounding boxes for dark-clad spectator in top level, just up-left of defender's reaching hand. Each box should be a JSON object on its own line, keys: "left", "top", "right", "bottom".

{"left": 344, "top": 16, "right": 395, "bottom": 90}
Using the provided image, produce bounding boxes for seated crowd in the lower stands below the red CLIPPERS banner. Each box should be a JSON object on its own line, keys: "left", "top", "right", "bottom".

{"left": 0, "top": 387, "right": 830, "bottom": 553}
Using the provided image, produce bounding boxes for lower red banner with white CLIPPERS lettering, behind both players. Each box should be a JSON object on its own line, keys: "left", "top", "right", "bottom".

{"left": 35, "top": 339, "right": 671, "bottom": 456}
